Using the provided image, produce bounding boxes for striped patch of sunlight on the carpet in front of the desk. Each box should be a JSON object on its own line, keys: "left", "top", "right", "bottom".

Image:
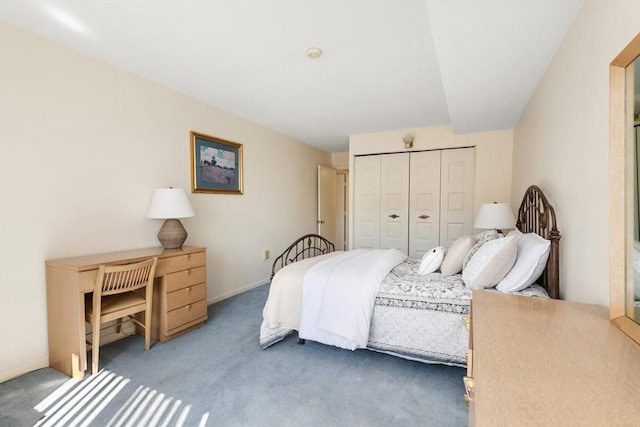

{"left": 34, "top": 369, "right": 209, "bottom": 427}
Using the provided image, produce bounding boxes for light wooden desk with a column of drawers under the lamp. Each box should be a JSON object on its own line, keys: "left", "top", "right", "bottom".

{"left": 45, "top": 246, "right": 207, "bottom": 378}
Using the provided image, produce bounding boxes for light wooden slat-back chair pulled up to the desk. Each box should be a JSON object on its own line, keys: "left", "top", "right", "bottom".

{"left": 85, "top": 257, "right": 158, "bottom": 374}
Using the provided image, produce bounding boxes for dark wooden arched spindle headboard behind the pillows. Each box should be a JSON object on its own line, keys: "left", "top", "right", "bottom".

{"left": 516, "top": 185, "right": 560, "bottom": 299}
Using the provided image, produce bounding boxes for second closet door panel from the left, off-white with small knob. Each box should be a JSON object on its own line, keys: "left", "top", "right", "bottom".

{"left": 380, "top": 153, "right": 409, "bottom": 254}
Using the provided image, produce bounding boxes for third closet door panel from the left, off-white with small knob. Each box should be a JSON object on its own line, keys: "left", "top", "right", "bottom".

{"left": 408, "top": 151, "right": 441, "bottom": 259}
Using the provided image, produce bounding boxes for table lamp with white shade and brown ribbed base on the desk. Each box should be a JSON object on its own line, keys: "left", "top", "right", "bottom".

{"left": 147, "top": 187, "right": 195, "bottom": 249}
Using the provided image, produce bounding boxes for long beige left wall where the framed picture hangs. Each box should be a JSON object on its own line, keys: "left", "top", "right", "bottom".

{"left": 0, "top": 22, "right": 331, "bottom": 381}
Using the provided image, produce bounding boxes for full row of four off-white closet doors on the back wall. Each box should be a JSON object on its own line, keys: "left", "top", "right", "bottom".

{"left": 353, "top": 148, "right": 475, "bottom": 259}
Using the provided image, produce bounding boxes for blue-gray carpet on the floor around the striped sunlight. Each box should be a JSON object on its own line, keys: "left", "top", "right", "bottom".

{"left": 0, "top": 285, "right": 467, "bottom": 427}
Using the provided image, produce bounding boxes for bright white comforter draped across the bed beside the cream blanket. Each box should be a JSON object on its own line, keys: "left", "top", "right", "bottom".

{"left": 296, "top": 249, "right": 407, "bottom": 350}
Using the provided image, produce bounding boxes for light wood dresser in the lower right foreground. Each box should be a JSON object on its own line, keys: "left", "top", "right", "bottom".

{"left": 465, "top": 291, "right": 640, "bottom": 427}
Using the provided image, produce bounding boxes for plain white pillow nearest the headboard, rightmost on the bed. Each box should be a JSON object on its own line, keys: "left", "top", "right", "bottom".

{"left": 496, "top": 230, "right": 551, "bottom": 292}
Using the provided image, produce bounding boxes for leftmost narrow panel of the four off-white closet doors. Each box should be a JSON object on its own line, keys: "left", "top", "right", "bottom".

{"left": 353, "top": 156, "right": 381, "bottom": 249}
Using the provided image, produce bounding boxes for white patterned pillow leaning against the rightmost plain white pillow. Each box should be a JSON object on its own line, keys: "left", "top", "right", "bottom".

{"left": 462, "top": 236, "right": 518, "bottom": 289}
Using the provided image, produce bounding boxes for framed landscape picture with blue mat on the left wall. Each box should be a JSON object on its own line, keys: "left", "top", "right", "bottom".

{"left": 191, "top": 132, "right": 243, "bottom": 194}
